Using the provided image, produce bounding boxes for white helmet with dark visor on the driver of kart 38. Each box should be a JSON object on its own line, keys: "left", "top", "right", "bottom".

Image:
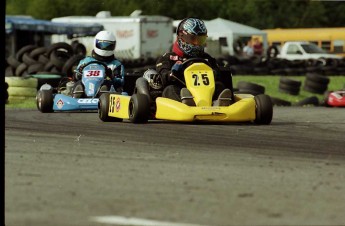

{"left": 93, "top": 31, "right": 116, "bottom": 57}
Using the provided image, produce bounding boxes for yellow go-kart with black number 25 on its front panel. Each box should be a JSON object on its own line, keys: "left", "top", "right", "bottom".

{"left": 98, "top": 58, "right": 273, "bottom": 124}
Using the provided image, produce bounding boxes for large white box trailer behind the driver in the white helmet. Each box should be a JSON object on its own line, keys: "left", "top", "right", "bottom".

{"left": 52, "top": 11, "right": 173, "bottom": 60}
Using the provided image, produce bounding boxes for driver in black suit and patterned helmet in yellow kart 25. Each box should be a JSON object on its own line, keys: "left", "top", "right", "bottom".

{"left": 136, "top": 17, "right": 232, "bottom": 106}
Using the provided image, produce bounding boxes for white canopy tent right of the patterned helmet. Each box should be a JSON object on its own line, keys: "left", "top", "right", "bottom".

{"left": 173, "top": 18, "right": 268, "bottom": 55}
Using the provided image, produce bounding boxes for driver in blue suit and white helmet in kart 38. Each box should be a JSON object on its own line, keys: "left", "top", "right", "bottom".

{"left": 74, "top": 31, "right": 125, "bottom": 98}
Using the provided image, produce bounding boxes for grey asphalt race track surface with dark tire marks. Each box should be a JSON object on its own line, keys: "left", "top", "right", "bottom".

{"left": 5, "top": 107, "right": 345, "bottom": 226}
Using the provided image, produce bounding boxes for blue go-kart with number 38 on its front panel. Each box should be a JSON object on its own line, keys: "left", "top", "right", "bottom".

{"left": 36, "top": 61, "right": 115, "bottom": 113}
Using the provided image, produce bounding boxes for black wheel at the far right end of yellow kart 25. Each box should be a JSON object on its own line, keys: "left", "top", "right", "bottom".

{"left": 254, "top": 94, "right": 273, "bottom": 125}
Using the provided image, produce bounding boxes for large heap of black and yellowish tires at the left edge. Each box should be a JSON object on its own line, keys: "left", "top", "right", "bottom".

{"left": 5, "top": 42, "right": 86, "bottom": 101}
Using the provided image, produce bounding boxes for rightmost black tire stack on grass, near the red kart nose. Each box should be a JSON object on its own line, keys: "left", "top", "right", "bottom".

{"left": 303, "top": 73, "right": 330, "bottom": 94}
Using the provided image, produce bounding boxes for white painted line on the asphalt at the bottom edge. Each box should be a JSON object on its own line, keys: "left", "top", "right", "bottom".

{"left": 92, "top": 216, "right": 206, "bottom": 226}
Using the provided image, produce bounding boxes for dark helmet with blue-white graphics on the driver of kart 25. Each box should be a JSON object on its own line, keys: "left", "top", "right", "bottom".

{"left": 176, "top": 17, "right": 207, "bottom": 57}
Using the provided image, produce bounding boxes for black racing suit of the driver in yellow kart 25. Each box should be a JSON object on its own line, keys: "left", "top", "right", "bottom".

{"left": 156, "top": 52, "right": 225, "bottom": 101}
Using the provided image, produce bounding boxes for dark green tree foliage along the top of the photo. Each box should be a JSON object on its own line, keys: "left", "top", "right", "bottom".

{"left": 6, "top": 0, "right": 345, "bottom": 29}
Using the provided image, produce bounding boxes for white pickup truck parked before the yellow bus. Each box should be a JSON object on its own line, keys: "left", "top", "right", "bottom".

{"left": 270, "top": 42, "right": 342, "bottom": 60}
